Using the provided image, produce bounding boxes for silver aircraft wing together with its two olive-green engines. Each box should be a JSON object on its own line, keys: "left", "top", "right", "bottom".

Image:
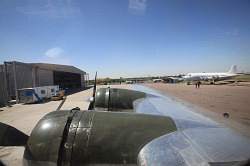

{"left": 0, "top": 85, "right": 250, "bottom": 166}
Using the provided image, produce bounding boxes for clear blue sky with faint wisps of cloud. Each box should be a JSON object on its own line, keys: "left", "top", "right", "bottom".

{"left": 0, "top": 0, "right": 250, "bottom": 78}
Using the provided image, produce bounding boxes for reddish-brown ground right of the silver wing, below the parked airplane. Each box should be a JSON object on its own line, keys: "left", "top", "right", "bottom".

{"left": 144, "top": 83, "right": 250, "bottom": 137}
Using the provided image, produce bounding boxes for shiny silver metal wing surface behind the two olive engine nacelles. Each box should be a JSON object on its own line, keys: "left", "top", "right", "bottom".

{"left": 134, "top": 86, "right": 250, "bottom": 166}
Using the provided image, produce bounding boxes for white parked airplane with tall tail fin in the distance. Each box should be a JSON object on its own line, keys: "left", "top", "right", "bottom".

{"left": 183, "top": 65, "right": 239, "bottom": 82}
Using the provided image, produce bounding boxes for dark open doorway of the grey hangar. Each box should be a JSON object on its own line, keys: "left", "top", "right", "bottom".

{"left": 53, "top": 71, "right": 81, "bottom": 90}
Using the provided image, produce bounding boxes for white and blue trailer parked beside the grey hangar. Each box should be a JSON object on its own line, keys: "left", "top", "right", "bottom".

{"left": 18, "top": 85, "right": 59, "bottom": 104}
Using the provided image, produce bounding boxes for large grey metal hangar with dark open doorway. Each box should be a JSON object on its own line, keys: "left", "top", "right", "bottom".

{"left": 0, "top": 61, "right": 88, "bottom": 105}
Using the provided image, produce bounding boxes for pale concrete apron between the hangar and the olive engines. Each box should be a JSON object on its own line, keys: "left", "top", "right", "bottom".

{"left": 0, "top": 85, "right": 130, "bottom": 166}
